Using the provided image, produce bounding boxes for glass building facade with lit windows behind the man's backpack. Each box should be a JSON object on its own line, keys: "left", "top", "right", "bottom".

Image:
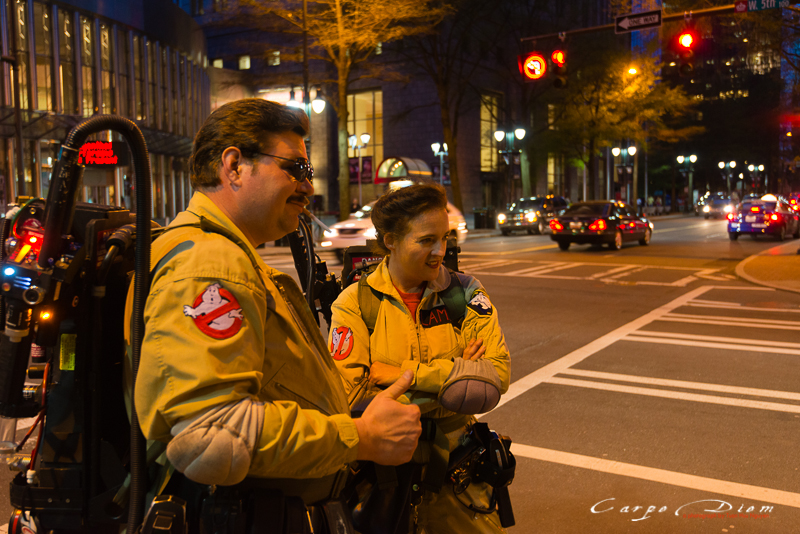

{"left": 0, "top": 0, "right": 211, "bottom": 222}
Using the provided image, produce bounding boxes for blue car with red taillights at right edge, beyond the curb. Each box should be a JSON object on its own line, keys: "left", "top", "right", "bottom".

{"left": 728, "top": 195, "right": 800, "bottom": 241}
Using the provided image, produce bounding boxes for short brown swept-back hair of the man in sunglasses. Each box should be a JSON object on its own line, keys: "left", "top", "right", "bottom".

{"left": 189, "top": 98, "right": 308, "bottom": 188}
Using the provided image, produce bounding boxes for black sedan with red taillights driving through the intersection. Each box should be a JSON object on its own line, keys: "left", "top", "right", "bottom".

{"left": 550, "top": 200, "right": 653, "bottom": 250}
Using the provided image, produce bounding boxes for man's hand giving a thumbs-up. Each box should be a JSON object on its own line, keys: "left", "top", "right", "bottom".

{"left": 355, "top": 371, "right": 422, "bottom": 465}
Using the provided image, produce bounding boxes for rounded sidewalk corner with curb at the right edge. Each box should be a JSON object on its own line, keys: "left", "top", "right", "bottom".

{"left": 736, "top": 240, "right": 800, "bottom": 293}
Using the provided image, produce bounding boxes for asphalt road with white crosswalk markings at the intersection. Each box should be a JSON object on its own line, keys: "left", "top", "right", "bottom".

{"left": 0, "top": 217, "right": 800, "bottom": 534}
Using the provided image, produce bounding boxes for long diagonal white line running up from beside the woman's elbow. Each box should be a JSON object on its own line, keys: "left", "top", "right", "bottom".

{"left": 484, "top": 286, "right": 714, "bottom": 415}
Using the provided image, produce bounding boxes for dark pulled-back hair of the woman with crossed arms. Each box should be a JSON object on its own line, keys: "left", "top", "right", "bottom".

{"left": 371, "top": 183, "right": 447, "bottom": 254}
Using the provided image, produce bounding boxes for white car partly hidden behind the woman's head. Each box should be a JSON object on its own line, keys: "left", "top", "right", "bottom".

{"left": 319, "top": 201, "right": 468, "bottom": 260}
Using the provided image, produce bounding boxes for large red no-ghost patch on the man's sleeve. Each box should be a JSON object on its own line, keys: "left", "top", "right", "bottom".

{"left": 183, "top": 282, "right": 244, "bottom": 339}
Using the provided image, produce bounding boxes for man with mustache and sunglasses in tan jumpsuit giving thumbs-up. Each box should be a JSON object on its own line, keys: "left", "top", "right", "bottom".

{"left": 129, "top": 99, "right": 421, "bottom": 532}
